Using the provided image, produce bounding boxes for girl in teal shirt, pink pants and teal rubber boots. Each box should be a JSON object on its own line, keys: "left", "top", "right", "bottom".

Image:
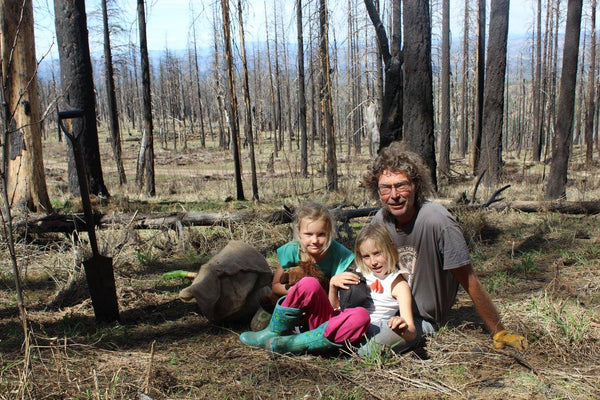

{"left": 240, "top": 202, "right": 369, "bottom": 353}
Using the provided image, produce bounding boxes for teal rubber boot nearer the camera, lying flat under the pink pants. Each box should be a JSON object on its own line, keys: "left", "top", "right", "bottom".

{"left": 265, "top": 322, "right": 342, "bottom": 354}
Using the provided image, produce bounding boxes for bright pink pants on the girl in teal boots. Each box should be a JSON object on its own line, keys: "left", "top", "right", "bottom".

{"left": 281, "top": 277, "right": 371, "bottom": 343}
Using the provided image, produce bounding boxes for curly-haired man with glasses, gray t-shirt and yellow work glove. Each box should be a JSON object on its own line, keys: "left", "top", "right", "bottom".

{"left": 362, "top": 142, "right": 527, "bottom": 350}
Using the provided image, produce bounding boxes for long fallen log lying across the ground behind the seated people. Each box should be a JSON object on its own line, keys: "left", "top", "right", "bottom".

{"left": 15, "top": 200, "right": 600, "bottom": 234}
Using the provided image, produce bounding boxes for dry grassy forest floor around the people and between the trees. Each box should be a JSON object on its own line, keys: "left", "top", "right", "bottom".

{"left": 0, "top": 130, "right": 600, "bottom": 400}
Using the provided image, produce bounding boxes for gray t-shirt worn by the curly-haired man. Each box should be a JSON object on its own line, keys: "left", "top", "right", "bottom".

{"left": 371, "top": 201, "right": 471, "bottom": 324}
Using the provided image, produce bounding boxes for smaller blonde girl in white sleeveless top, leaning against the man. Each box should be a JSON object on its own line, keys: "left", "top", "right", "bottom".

{"left": 354, "top": 224, "right": 417, "bottom": 356}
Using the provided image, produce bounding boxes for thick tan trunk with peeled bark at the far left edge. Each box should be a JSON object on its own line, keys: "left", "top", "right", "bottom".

{"left": 0, "top": 0, "right": 52, "bottom": 212}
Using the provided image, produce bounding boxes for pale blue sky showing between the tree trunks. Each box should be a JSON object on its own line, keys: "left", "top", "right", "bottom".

{"left": 34, "top": 0, "right": 533, "bottom": 59}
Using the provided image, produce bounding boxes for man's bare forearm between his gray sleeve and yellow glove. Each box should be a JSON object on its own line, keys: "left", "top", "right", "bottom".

{"left": 452, "top": 264, "right": 504, "bottom": 335}
